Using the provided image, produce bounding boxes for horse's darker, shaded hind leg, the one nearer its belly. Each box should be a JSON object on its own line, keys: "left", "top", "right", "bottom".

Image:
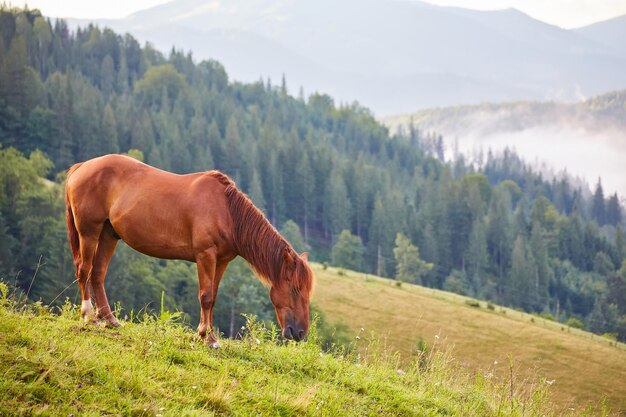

{"left": 91, "top": 221, "right": 121, "bottom": 327}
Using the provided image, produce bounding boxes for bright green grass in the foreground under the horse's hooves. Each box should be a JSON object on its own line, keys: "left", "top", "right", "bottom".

{"left": 0, "top": 282, "right": 591, "bottom": 416}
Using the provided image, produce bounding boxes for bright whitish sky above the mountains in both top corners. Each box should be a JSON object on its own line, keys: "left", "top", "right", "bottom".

{"left": 9, "top": 0, "right": 626, "bottom": 29}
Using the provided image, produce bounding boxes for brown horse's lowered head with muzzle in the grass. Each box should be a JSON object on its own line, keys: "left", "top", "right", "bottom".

{"left": 270, "top": 248, "right": 313, "bottom": 342}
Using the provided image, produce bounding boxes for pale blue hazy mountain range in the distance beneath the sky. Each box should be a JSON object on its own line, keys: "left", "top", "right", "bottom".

{"left": 66, "top": 0, "right": 626, "bottom": 115}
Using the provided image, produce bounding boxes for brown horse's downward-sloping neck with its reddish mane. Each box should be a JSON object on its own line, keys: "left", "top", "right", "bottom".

{"left": 209, "top": 171, "right": 312, "bottom": 292}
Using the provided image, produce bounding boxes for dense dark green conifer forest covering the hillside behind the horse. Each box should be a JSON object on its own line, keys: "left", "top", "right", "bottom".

{"left": 0, "top": 6, "right": 626, "bottom": 341}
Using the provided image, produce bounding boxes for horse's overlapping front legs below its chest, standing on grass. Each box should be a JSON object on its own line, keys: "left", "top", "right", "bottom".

{"left": 196, "top": 251, "right": 228, "bottom": 348}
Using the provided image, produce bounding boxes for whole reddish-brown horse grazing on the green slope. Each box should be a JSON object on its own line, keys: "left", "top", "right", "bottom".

{"left": 65, "top": 155, "right": 313, "bottom": 347}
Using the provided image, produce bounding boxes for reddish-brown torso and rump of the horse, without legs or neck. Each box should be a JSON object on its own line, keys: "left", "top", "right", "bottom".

{"left": 67, "top": 155, "right": 230, "bottom": 259}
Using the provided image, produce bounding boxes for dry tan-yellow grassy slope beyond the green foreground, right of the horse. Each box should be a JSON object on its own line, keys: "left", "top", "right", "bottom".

{"left": 314, "top": 266, "right": 626, "bottom": 414}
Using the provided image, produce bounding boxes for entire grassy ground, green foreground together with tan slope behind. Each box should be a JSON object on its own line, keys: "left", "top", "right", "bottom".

{"left": 0, "top": 265, "right": 626, "bottom": 417}
